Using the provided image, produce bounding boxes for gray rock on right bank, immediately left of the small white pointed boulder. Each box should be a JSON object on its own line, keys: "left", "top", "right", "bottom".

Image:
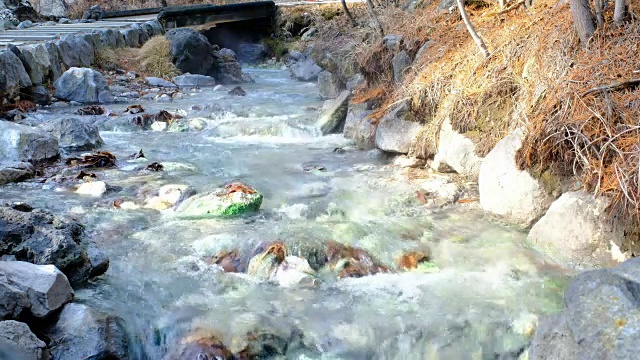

{"left": 376, "top": 103, "right": 422, "bottom": 154}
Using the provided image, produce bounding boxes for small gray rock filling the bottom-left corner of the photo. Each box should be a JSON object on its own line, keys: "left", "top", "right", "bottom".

{"left": 0, "top": 320, "right": 48, "bottom": 360}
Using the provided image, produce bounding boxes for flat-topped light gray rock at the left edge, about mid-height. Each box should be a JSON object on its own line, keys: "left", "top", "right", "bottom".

{"left": 0, "top": 120, "right": 58, "bottom": 162}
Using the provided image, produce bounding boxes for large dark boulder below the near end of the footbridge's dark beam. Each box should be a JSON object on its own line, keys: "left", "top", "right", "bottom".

{"left": 166, "top": 28, "right": 214, "bottom": 75}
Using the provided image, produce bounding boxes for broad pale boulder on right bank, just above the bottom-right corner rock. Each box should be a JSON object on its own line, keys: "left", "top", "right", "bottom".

{"left": 527, "top": 191, "right": 640, "bottom": 268}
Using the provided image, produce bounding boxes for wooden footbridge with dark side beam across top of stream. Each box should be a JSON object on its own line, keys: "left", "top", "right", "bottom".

{"left": 0, "top": 0, "right": 361, "bottom": 48}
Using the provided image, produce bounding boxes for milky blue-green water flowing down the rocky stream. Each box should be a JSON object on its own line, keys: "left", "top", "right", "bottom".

{"left": 0, "top": 70, "right": 566, "bottom": 360}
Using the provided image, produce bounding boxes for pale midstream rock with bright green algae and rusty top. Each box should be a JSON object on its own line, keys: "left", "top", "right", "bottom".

{"left": 176, "top": 183, "right": 262, "bottom": 218}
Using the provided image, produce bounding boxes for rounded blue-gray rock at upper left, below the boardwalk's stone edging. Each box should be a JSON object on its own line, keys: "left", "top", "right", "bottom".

{"left": 54, "top": 67, "right": 113, "bottom": 104}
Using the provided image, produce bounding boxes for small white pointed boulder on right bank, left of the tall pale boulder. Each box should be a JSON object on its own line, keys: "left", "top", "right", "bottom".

{"left": 431, "top": 119, "right": 482, "bottom": 178}
